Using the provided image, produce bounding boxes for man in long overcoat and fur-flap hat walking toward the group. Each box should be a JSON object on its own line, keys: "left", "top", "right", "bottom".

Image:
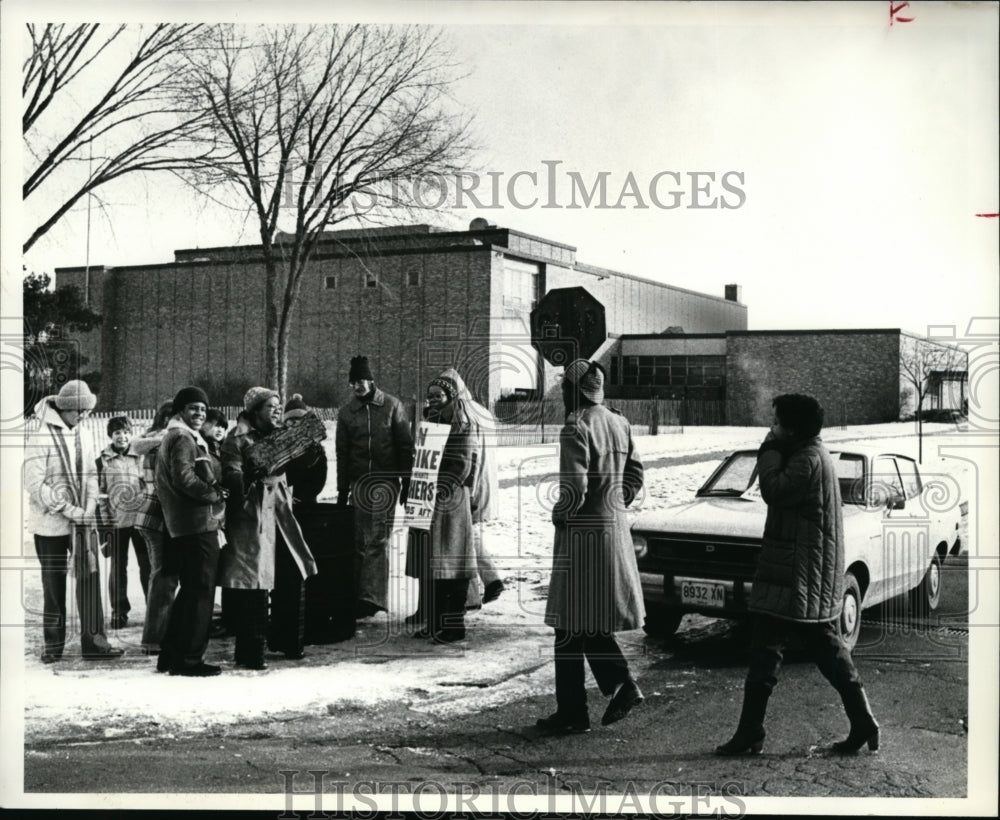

{"left": 537, "top": 359, "right": 645, "bottom": 734}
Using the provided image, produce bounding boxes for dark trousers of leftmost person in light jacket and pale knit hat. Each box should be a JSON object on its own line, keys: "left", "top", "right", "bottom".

{"left": 35, "top": 535, "right": 110, "bottom": 658}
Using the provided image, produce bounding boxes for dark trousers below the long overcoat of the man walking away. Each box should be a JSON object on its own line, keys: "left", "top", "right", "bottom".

{"left": 555, "top": 629, "right": 629, "bottom": 714}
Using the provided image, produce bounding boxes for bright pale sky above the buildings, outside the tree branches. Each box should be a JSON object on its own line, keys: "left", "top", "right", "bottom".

{"left": 4, "top": 2, "right": 1000, "bottom": 335}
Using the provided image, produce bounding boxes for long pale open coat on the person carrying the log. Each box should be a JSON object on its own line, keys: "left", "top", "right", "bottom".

{"left": 219, "top": 415, "right": 316, "bottom": 589}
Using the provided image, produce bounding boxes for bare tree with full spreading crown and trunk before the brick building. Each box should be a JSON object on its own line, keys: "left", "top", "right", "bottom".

{"left": 181, "top": 25, "right": 468, "bottom": 393}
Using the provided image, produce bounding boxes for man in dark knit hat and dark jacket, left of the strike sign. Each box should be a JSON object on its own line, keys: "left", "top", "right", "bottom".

{"left": 336, "top": 356, "right": 413, "bottom": 618}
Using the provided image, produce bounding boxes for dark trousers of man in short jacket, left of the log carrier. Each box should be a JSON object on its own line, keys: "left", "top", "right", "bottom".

{"left": 163, "top": 532, "right": 219, "bottom": 668}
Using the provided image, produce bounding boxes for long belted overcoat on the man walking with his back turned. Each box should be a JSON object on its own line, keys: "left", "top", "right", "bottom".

{"left": 545, "top": 404, "right": 646, "bottom": 635}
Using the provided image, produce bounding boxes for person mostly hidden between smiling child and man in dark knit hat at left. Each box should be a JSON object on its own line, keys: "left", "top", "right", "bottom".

{"left": 132, "top": 399, "right": 180, "bottom": 656}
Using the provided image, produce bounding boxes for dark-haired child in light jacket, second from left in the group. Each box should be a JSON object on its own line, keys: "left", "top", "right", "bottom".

{"left": 97, "top": 416, "right": 149, "bottom": 629}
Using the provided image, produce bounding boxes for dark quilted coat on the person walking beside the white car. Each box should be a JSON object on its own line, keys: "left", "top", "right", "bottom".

{"left": 748, "top": 437, "right": 844, "bottom": 623}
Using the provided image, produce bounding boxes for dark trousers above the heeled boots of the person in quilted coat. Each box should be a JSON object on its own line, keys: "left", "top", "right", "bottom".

{"left": 747, "top": 615, "right": 860, "bottom": 693}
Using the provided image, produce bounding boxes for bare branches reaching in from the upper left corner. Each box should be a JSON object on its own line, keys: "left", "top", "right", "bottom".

{"left": 21, "top": 23, "right": 219, "bottom": 251}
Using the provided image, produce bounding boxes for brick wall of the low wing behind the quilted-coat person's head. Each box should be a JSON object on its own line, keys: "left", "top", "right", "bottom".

{"left": 726, "top": 330, "right": 900, "bottom": 426}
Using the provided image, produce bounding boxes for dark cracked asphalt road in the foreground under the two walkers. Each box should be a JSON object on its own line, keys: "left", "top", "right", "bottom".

{"left": 24, "top": 559, "right": 969, "bottom": 800}
